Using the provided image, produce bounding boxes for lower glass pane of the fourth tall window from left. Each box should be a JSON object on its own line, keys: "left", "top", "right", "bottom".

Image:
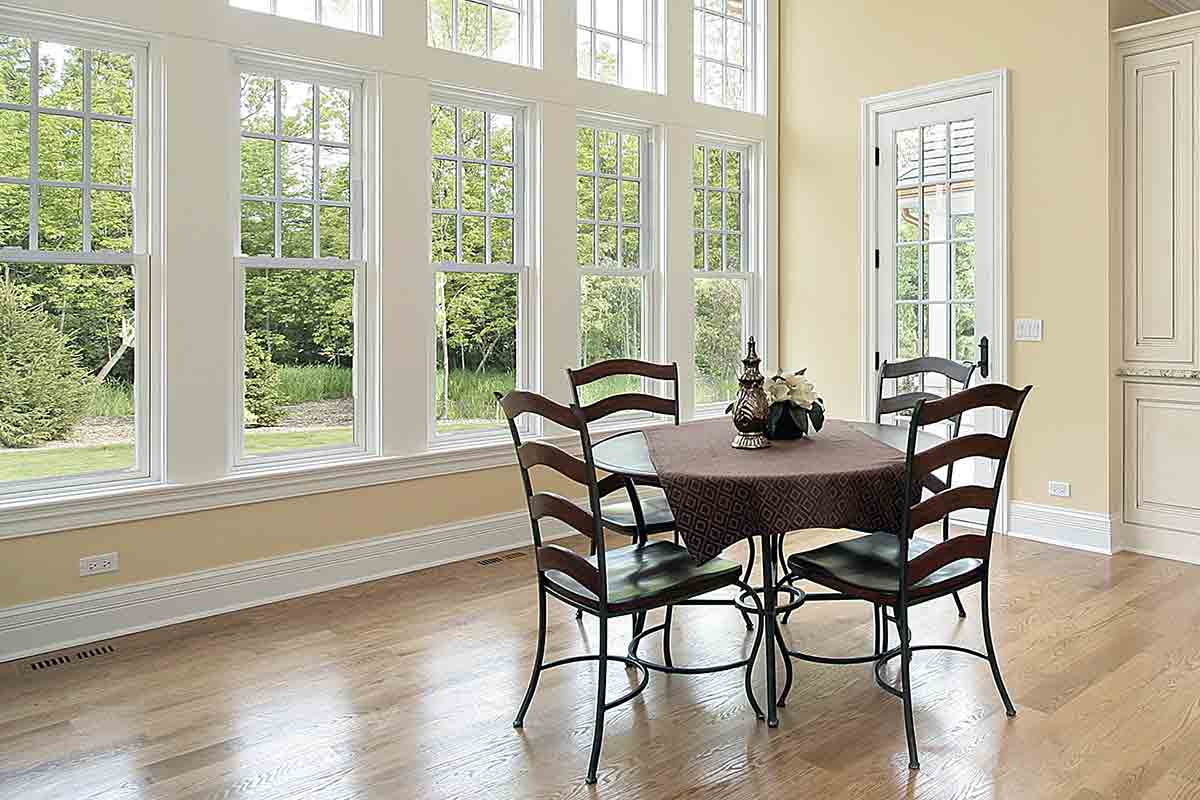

{"left": 580, "top": 275, "right": 644, "bottom": 403}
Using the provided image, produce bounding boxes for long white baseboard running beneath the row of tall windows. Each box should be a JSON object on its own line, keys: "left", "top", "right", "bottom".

{"left": 0, "top": 511, "right": 574, "bottom": 662}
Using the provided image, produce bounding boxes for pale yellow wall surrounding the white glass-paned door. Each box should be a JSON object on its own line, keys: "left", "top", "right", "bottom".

{"left": 780, "top": 0, "right": 1120, "bottom": 512}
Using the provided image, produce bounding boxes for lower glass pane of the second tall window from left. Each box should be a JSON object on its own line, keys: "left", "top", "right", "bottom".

{"left": 244, "top": 269, "right": 354, "bottom": 457}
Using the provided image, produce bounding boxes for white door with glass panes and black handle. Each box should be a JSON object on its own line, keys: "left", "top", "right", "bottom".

{"left": 872, "top": 95, "right": 1003, "bottom": 522}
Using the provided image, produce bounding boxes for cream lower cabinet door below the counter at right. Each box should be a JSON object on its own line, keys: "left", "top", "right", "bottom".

{"left": 1124, "top": 384, "right": 1200, "bottom": 533}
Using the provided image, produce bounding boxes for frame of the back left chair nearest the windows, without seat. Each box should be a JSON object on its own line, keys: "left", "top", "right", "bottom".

{"left": 566, "top": 359, "right": 755, "bottom": 647}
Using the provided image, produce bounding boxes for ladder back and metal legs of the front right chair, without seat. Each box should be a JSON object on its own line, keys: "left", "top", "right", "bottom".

{"left": 780, "top": 384, "right": 1033, "bottom": 770}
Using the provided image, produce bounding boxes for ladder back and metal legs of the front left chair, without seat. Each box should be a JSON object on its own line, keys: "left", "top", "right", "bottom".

{"left": 496, "top": 391, "right": 762, "bottom": 784}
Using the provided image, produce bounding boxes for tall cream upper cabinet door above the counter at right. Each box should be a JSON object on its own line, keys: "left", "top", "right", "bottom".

{"left": 1122, "top": 44, "right": 1195, "bottom": 363}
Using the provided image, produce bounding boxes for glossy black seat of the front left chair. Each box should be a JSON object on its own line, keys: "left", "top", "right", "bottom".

{"left": 546, "top": 541, "right": 742, "bottom": 614}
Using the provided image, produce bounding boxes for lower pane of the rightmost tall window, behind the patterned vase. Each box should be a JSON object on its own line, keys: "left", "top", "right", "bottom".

{"left": 696, "top": 278, "right": 745, "bottom": 405}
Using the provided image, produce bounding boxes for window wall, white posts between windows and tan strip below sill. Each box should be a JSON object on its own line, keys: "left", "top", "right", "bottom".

{"left": 0, "top": 0, "right": 778, "bottom": 608}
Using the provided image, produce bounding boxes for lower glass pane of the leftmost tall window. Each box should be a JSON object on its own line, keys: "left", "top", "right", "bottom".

{"left": 0, "top": 264, "right": 137, "bottom": 482}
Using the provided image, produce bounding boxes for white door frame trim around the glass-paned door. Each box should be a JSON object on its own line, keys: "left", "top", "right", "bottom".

{"left": 858, "top": 70, "right": 1009, "bottom": 533}
